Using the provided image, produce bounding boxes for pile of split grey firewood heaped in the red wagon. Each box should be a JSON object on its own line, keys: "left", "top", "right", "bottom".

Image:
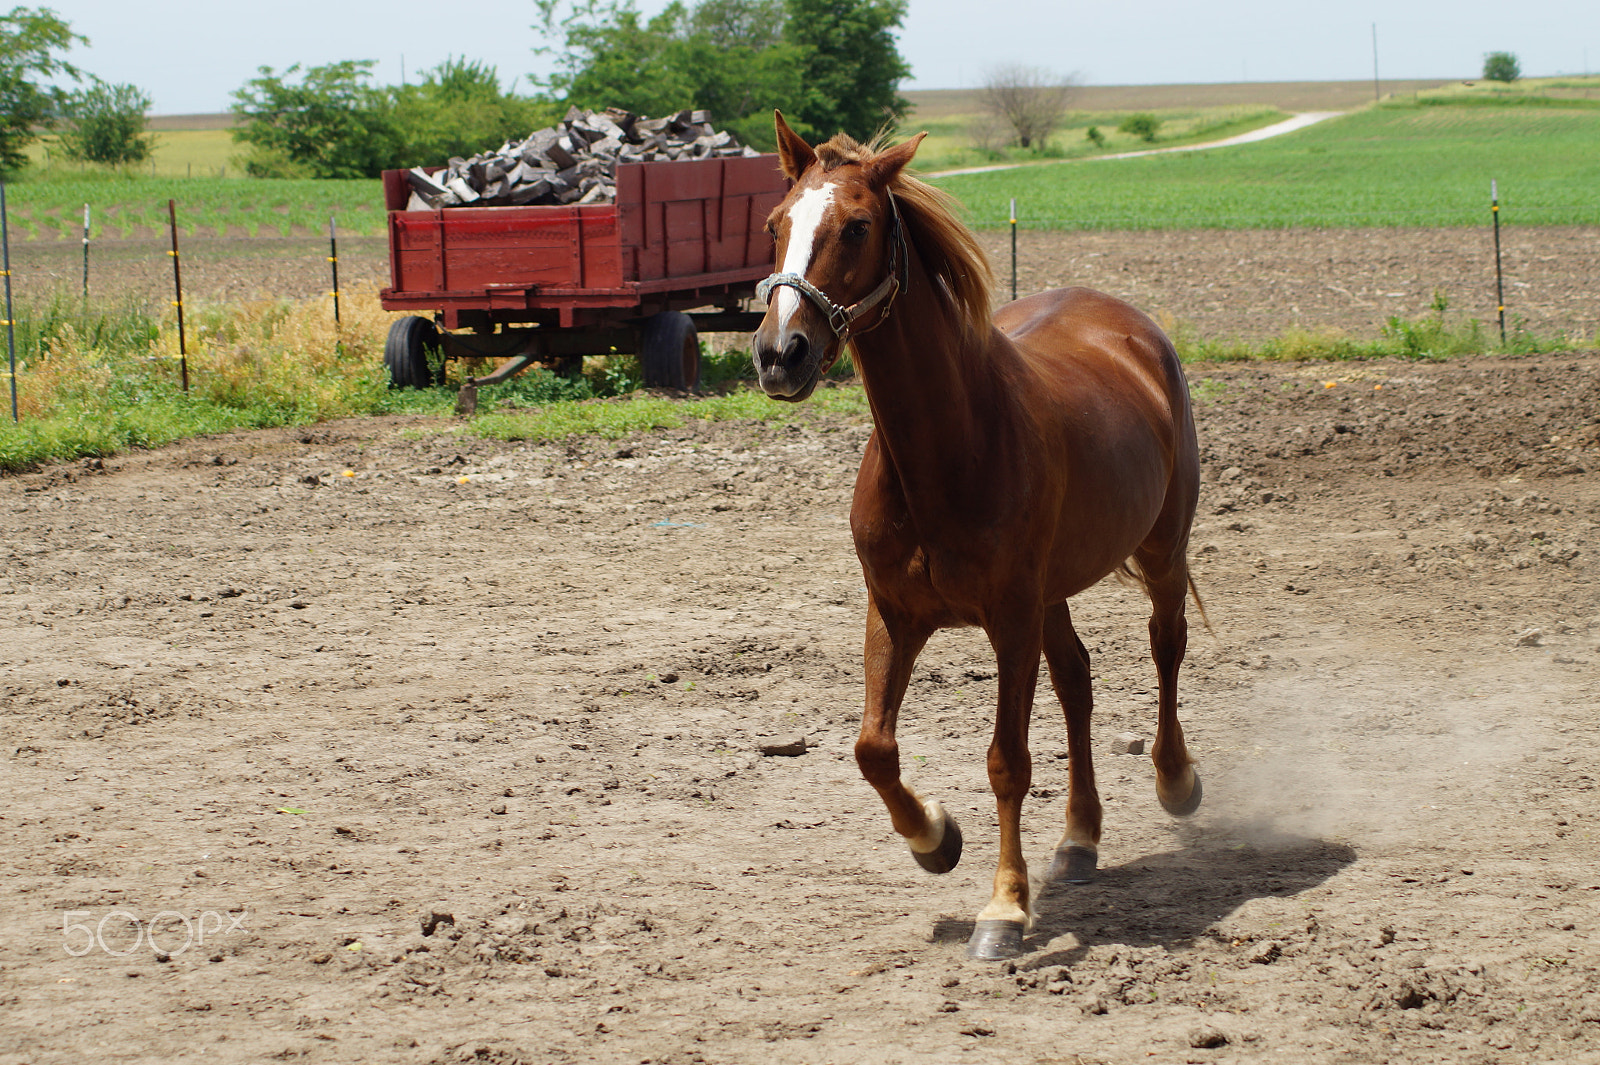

{"left": 406, "top": 107, "right": 758, "bottom": 211}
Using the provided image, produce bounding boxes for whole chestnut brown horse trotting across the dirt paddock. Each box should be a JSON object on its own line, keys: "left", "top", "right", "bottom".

{"left": 754, "top": 115, "right": 1200, "bottom": 958}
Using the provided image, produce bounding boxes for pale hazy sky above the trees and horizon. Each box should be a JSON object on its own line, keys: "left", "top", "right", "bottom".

{"left": 56, "top": 0, "right": 1600, "bottom": 115}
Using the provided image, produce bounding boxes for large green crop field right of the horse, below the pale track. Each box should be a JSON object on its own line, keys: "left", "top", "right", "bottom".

{"left": 938, "top": 80, "right": 1600, "bottom": 229}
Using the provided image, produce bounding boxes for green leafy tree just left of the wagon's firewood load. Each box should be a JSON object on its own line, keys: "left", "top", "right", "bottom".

{"left": 232, "top": 59, "right": 403, "bottom": 178}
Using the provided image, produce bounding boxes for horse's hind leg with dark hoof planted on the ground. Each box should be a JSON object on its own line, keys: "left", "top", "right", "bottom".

{"left": 1045, "top": 603, "right": 1101, "bottom": 884}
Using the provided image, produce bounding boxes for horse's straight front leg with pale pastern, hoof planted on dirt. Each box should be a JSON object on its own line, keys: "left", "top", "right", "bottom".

{"left": 966, "top": 611, "right": 1042, "bottom": 959}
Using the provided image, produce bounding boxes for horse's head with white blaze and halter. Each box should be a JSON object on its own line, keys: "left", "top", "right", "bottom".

{"left": 754, "top": 114, "right": 926, "bottom": 401}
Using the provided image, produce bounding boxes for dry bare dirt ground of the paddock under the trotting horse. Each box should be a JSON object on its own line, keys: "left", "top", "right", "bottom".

{"left": 0, "top": 329, "right": 1600, "bottom": 1065}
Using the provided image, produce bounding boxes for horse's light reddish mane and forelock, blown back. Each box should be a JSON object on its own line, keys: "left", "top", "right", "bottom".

{"left": 816, "top": 133, "right": 994, "bottom": 329}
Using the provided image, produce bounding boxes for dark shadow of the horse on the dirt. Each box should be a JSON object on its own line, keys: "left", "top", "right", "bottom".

{"left": 933, "top": 835, "right": 1355, "bottom": 969}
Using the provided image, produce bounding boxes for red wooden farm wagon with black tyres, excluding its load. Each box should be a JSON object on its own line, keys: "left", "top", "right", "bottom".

{"left": 379, "top": 155, "right": 787, "bottom": 389}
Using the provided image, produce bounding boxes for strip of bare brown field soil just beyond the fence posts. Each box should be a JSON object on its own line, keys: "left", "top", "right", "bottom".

{"left": 13, "top": 225, "right": 1600, "bottom": 347}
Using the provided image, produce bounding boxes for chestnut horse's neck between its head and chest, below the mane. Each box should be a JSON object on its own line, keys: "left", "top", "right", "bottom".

{"left": 854, "top": 254, "right": 1019, "bottom": 509}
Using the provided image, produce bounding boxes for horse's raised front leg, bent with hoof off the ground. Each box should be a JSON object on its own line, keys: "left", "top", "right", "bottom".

{"left": 856, "top": 593, "right": 962, "bottom": 873}
